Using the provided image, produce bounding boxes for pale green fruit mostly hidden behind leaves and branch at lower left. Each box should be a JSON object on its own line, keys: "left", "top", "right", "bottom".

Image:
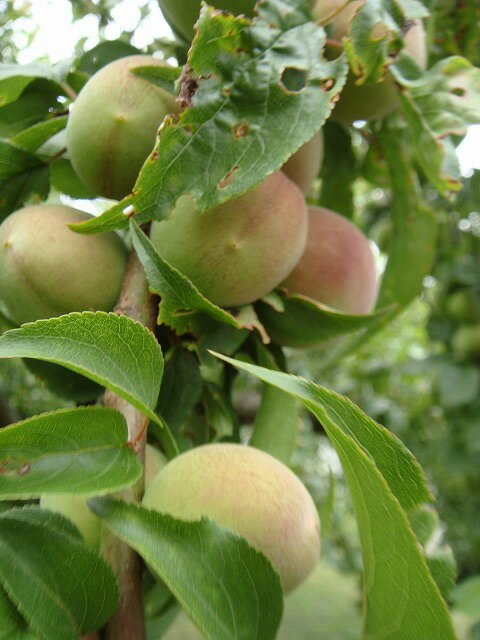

{"left": 40, "top": 444, "right": 167, "bottom": 549}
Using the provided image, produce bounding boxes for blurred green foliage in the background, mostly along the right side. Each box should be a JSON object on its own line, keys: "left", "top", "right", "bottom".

{"left": 0, "top": 0, "right": 480, "bottom": 640}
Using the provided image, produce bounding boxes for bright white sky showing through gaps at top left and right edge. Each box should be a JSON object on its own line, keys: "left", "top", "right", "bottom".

{"left": 10, "top": 0, "right": 480, "bottom": 175}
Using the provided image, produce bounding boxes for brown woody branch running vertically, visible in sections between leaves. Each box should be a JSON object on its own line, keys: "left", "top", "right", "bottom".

{"left": 101, "top": 251, "right": 156, "bottom": 640}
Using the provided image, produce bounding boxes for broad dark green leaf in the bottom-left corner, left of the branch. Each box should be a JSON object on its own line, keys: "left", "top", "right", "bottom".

{"left": 0, "top": 507, "right": 119, "bottom": 640}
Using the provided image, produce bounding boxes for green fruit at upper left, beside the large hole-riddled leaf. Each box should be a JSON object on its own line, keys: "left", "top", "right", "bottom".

{"left": 66, "top": 56, "right": 177, "bottom": 200}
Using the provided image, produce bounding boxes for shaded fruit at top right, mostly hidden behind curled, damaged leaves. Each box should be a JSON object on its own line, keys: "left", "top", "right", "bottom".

{"left": 310, "top": 0, "right": 427, "bottom": 123}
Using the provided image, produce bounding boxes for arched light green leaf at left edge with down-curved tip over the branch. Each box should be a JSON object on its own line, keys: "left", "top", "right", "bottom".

{"left": 0, "top": 311, "right": 163, "bottom": 423}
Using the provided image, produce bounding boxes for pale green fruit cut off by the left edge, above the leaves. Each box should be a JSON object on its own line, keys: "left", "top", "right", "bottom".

{"left": 0, "top": 205, "right": 128, "bottom": 324}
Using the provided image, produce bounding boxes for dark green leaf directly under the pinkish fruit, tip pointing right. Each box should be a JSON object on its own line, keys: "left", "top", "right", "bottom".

{"left": 255, "top": 294, "right": 390, "bottom": 348}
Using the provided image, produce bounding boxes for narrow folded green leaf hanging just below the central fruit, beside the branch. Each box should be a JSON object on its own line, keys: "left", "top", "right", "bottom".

{"left": 130, "top": 220, "right": 242, "bottom": 333}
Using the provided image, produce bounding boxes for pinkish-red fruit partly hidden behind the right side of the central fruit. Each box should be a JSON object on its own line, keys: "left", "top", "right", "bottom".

{"left": 281, "top": 207, "right": 378, "bottom": 315}
